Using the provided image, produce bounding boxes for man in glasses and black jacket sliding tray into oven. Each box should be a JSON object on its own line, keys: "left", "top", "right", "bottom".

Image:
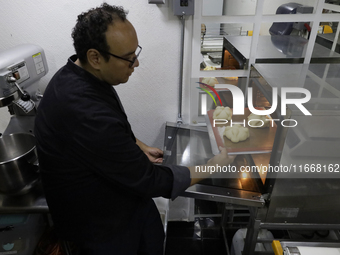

{"left": 35, "top": 3, "right": 233, "bottom": 255}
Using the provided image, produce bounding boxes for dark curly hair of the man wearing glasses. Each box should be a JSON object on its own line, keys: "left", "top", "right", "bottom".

{"left": 72, "top": 3, "right": 127, "bottom": 63}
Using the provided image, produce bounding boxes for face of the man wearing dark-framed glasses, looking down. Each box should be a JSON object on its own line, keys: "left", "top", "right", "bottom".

{"left": 100, "top": 20, "right": 139, "bottom": 85}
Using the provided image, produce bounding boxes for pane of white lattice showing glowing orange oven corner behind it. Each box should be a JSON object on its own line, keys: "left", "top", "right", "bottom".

{"left": 201, "top": 23, "right": 253, "bottom": 71}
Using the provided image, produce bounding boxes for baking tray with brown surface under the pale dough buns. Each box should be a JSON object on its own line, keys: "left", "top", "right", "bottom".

{"left": 205, "top": 108, "right": 276, "bottom": 155}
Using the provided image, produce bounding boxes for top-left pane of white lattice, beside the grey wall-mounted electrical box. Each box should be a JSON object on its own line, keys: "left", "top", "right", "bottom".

{"left": 202, "top": 0, "right": 257, "bottom": 16}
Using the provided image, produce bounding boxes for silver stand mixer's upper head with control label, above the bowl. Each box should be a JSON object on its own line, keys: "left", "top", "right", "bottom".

{"left": 0, "top": 44, "right": 48, "bottom": 116}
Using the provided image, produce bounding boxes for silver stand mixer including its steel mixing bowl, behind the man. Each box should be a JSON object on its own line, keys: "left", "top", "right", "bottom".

{"left": 0, "top": 44, "right": 48, "bottom": 195}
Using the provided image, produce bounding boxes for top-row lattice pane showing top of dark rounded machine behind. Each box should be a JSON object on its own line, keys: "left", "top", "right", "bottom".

{"left": 263, "top": 0, "right": 317, "bottom": 15}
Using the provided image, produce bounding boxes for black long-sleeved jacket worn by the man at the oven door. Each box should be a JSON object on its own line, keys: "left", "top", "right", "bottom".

{"left": 34, "top": 56, "right": 190, "bottom": 241}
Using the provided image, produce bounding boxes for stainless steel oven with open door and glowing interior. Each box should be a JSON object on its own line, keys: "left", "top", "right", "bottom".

{"left": 165, "top": 64, "right": 340, "bottom": 254}
